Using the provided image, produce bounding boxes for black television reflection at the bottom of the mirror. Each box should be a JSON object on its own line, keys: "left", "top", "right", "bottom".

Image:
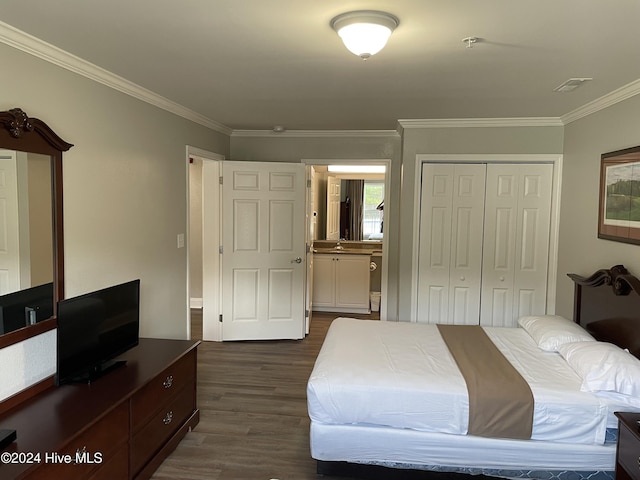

{"left": 0, "top": 282, "right": 53, "bottom": 334}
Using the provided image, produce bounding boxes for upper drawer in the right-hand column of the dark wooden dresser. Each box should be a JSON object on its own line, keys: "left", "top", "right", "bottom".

{"left": 131, "top": 350, "right": 196, "bottom": 428}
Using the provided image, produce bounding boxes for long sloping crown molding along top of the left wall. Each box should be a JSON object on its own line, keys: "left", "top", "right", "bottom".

{"left": 0, "top": 22, "right": 233, "bottom": 135}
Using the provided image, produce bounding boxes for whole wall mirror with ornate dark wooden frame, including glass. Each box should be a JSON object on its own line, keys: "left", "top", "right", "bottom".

{"left": 0, "top": 108, "right": 72, "bottom": 348}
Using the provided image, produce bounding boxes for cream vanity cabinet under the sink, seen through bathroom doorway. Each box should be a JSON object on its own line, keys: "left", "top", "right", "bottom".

{"left": 312, "top": 253, "right": 371, "bottom": 313}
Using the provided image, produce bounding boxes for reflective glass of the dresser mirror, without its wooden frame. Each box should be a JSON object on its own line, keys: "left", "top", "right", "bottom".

{"left": 0, "top": 150, "right": 54, "bottom": 334}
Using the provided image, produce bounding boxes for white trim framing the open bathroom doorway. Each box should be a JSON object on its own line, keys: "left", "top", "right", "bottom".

{"left": 300, "top": 158, "right": 392, "bottom": 321}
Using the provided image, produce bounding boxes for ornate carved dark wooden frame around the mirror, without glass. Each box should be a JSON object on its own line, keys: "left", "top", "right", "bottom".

{"left": 0, "top": 108, "right": 73, "bottom": 348}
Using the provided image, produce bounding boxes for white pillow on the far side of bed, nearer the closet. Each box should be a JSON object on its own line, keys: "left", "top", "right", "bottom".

{"left": 518, "top": 315, "right": 595, "bottom": 352}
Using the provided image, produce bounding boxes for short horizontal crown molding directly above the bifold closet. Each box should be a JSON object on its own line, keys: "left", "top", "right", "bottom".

{"left": 398, "top": 117, "right": 563, "bottom": 129}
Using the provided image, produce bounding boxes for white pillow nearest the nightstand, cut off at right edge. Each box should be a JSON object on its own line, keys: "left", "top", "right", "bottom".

{"left": 558, "top": 342, "right": 640, "bottom": 397}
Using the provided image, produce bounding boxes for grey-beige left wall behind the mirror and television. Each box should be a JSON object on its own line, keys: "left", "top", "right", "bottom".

{"left": 0, "top": 44, "right": 229, "bottom": 399}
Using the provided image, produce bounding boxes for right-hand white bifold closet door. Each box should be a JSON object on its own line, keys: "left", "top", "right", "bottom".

{"left": 480, "top": 164, "right": 553, "bottom": 327}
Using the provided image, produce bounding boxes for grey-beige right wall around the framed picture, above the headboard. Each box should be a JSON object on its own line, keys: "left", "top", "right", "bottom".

{"left": 556, "top": 95, "right": 640, "bottom": 317}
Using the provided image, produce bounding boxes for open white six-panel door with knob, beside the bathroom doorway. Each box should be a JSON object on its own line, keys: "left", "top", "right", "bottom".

{"left": 222, "top": 161, "right": 306, "bottom": 340}
